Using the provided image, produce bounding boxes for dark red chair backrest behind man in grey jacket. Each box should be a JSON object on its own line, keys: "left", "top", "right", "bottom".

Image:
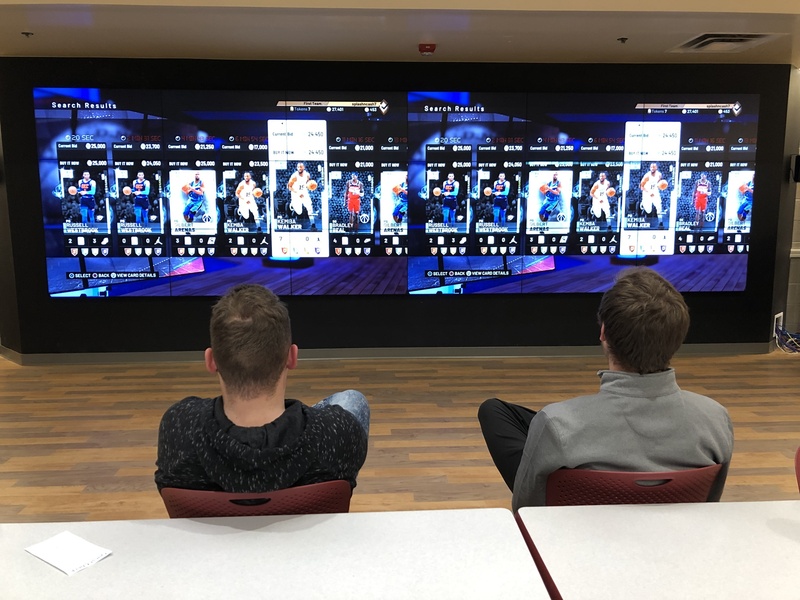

{"left": 545, "top": 465, "right": 722, "bottom": 506}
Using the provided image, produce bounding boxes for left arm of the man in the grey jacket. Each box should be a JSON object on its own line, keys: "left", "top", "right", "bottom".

{"left": 511, "top": 411, "right": 565, "bottom": 511}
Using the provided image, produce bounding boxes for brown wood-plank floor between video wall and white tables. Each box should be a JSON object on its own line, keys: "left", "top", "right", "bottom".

{"left": 0, "top": 352, "right": 800, "bottom": 522}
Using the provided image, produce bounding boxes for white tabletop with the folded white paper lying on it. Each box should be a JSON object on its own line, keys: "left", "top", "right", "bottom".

{"left": 0, "top": 508, "right": 548, "bottom": 600}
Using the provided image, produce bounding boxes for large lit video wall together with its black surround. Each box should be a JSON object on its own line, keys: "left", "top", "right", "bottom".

{"left": 0, "top": 59, "right": 796, "bottom": 353}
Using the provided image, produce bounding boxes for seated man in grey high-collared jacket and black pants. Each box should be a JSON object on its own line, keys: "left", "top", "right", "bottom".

{"left": 478, "top": 268, "right": 733, "bottom": 510}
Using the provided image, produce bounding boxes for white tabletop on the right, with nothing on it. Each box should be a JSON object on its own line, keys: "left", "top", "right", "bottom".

{"left": 519, "top": 501, "right": 800, "bottom": 600}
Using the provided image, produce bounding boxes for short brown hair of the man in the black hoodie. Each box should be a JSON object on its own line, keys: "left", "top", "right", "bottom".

{"left": 211, "top": 284, "right": 292, "bottom": 398}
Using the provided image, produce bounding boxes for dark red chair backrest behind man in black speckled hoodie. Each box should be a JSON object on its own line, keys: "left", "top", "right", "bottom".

{"left": 161, "top": 480, "right": 353, "bottom": 519}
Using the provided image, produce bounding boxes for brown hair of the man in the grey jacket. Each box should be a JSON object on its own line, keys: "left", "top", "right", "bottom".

{"left": 597, "top": 267, "right": 689, "bottom": 375}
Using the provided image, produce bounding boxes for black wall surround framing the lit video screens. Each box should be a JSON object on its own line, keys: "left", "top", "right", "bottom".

{"left": 0, "top": 59, "right": 791, "bottom": 353}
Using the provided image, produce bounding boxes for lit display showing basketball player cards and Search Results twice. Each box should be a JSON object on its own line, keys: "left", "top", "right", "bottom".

{"left": 34, "top": 87, "right": 759, "bottom": 297}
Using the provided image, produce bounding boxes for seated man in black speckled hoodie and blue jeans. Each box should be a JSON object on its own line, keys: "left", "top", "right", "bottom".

{"left": 155, "top": 284, "right": 369, "bottom": 492}
